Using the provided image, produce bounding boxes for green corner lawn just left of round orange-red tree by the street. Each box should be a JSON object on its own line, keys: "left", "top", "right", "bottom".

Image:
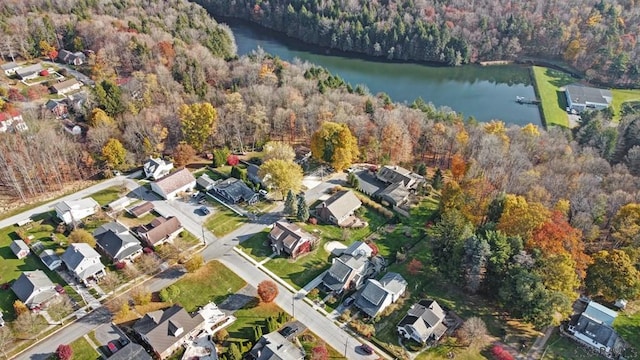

{"left": 170, "top": 261, "right": 246, "bottom": 312}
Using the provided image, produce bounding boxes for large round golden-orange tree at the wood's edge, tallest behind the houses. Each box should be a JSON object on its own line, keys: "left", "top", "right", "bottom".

{"left": 311, "top": 121, "right": 360, "bottom": 171}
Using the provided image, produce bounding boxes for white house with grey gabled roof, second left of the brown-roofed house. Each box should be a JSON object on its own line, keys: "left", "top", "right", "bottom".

{"left": 61, "top": 243, "right": 106, "bottom": 285}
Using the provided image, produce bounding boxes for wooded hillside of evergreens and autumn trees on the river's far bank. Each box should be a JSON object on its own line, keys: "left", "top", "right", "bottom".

{"left": 195, "top": 0, "right": 640, "bottom": 86}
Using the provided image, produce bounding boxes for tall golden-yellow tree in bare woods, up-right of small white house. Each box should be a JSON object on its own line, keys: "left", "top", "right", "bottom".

{"left": 178, "top": 103, "right": 218, "bottom": 151}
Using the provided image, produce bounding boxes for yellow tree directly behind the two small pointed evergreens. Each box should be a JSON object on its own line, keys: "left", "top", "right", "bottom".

{"left": 258, "top": 159, "right": 303, "bottom": 195}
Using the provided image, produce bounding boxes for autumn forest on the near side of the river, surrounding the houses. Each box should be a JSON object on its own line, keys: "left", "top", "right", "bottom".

{"left": 0, "top": 0, "right": 640, "bottom": 334}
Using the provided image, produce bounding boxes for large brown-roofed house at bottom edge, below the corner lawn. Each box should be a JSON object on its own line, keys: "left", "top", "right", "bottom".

{"left": 133, "top": 305, "right": 204, "bottom": 359}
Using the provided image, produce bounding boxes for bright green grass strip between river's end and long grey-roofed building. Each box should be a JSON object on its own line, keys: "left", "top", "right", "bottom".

{"left": 532, "top": 66, "right": 576, "bottom": 127}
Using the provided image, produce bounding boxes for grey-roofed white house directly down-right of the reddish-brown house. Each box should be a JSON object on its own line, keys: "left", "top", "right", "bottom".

{"left": 322, "top": 241, "right": 373, "bottom": 293}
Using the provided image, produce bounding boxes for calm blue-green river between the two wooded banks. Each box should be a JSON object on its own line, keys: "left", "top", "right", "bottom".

{"left": 221, "top": 19, "right": 541, "bottom": 125}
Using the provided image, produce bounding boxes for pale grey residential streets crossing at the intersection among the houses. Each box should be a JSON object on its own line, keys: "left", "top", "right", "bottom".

{"left": 13, "top": 170, "right": 377, "bottom": 360}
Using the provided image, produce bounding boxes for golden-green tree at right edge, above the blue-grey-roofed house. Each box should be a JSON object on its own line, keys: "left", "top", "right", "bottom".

{"left": 585, "top": 250, "right": 640, "bottom": 301}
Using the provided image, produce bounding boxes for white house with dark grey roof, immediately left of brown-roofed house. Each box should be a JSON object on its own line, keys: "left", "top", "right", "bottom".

{"left": 93, "top": 221, "right": 142, "bottom": 262}
